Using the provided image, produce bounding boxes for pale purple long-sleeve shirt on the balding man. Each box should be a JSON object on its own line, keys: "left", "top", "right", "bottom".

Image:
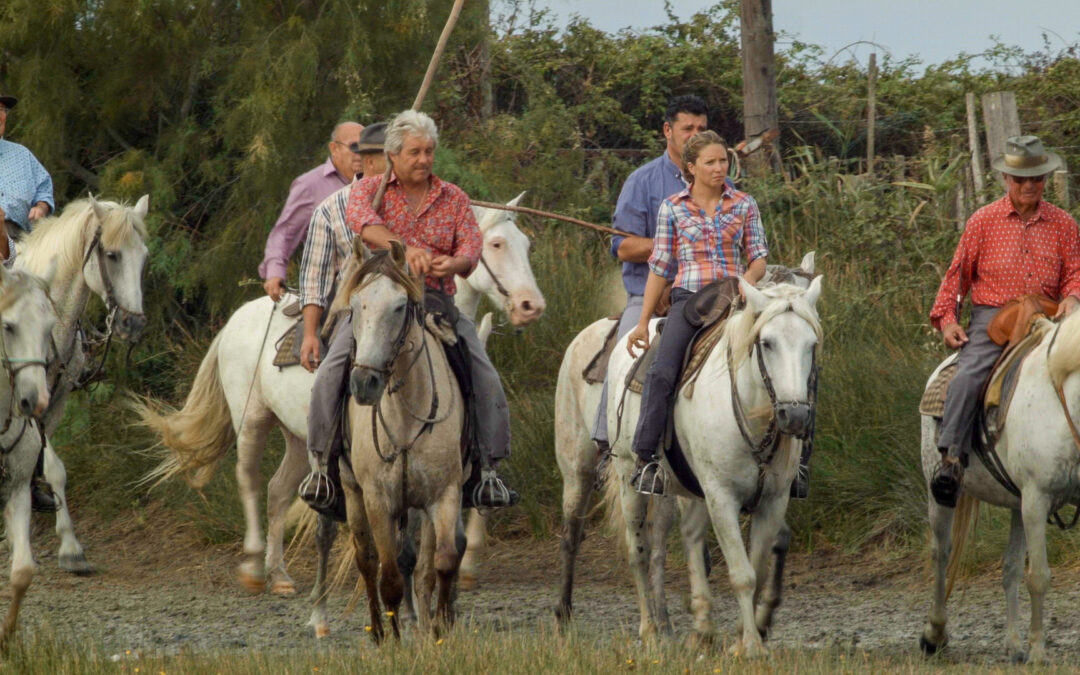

{"left": 259, "top": 158, "right": 350, "bottom": 279}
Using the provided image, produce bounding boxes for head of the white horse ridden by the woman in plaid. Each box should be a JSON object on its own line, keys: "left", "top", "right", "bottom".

{"left": 732, "top": 276, "right": 822, "bottom": 438}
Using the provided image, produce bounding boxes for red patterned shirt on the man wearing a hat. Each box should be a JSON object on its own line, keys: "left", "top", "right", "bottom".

{"left": 930, "top": 194, "right": 1080, "bottom": 330}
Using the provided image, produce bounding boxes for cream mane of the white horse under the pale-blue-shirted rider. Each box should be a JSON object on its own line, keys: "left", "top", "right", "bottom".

{"left": 19, "top": 199, "right": 148, "bottom": 279}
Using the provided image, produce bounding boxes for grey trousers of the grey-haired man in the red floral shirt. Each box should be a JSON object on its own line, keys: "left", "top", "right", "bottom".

{"left": 308, "top": 308, "right": 510, "bottom": 471}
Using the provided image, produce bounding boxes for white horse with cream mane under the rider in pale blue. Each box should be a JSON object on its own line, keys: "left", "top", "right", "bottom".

{"left": 15, "top": 195, "right": 149, "bottom": 573}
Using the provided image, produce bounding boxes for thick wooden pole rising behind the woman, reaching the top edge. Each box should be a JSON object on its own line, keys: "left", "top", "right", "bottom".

{"left": 741, "top": 0, "right": 780, "bottom": 175}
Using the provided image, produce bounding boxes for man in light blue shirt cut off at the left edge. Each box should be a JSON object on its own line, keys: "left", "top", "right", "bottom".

{"left": 0, "top": 95, "right": 56, "bottom": 258}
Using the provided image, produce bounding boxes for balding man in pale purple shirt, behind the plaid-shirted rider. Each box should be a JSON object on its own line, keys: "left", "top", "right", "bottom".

{"left": 259, "top": 122, "right": 364, "bottom": 302}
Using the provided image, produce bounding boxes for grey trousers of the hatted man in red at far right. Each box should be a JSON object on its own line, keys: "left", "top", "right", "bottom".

{"left": 937, "top": 305, "right": 1003, "bottom": 456}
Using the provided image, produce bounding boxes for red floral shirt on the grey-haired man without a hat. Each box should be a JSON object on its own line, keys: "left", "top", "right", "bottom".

{"left": 346, "top": 176, "right": 484, "bottom": 295}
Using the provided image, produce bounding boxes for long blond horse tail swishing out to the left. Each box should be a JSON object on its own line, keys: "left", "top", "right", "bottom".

{"left": 132, "top": 333, "right": 237, "bottom": 489}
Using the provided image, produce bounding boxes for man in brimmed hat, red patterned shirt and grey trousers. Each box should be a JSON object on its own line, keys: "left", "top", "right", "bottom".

{"left": 930, "top": 136, "right": 1080, "bottom": 507}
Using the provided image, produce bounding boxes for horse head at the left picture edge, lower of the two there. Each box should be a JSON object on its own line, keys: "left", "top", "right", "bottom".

{"left": 0, "top": 266, "right": 56, "bottom": 416}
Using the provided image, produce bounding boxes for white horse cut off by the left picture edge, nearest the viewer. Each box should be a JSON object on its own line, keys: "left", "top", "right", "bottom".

{"left": 0, "top": 266, "right": 56, "bottom": 647}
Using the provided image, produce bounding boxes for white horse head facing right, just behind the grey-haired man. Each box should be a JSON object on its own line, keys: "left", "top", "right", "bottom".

{"left": 465, "top": 192, "right": 546, "bottom": 326}
